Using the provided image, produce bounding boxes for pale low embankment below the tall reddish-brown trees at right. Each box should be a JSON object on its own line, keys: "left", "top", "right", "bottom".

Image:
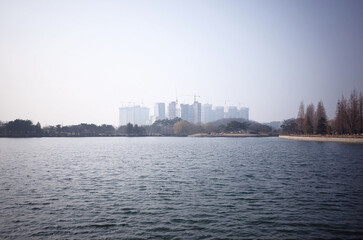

{"left": 279, "top": 135, "right": 363, "bottom": 144}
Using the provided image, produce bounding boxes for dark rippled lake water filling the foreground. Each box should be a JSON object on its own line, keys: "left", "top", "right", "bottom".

{"left": 0, "top": 137, "right": 363, "bottom": 239}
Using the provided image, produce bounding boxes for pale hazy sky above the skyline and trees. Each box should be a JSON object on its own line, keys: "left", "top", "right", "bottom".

{"left": 0, "top": 0, "right": 363, "bottom": 125}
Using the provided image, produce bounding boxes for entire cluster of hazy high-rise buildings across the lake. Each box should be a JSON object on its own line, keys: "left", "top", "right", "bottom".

{"left": 119, "top": 101, "right": 249, "bottom": 126}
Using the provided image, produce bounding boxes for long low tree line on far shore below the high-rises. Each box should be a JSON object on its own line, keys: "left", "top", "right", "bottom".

{"left": 0, "top": 118, "right": 272, "bottom": 137}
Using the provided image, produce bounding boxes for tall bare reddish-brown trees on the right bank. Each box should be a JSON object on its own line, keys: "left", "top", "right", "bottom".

{"left": 281, "top": 89, "right": 363, "bottom": 135}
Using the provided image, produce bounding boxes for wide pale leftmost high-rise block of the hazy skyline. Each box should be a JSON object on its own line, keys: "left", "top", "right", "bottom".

{"left": 119, "top": 106, "right": 149, "bottom": 126}
